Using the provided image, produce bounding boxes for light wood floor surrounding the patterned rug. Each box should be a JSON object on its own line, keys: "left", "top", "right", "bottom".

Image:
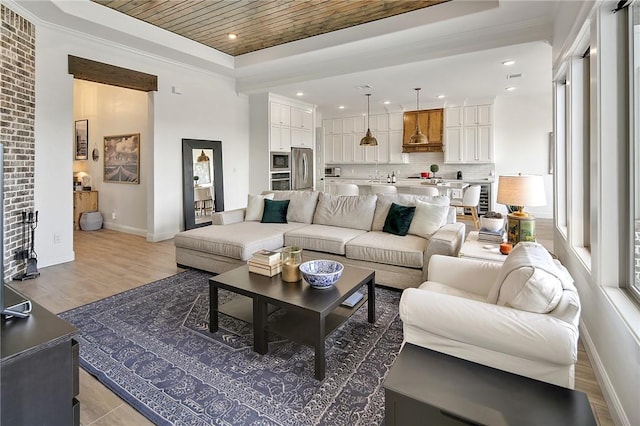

{"left": 6, "top": 228, "right": 613, "bottom": 426}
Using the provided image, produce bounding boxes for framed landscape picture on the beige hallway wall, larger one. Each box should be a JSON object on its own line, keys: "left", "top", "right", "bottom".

{"left": 103, "top": 133, "right": 140, "bottom": 184}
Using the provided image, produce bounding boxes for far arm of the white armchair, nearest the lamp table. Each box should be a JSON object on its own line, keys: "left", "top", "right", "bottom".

{"left": 428, "top": 254, "right": 502, "bottom": 298}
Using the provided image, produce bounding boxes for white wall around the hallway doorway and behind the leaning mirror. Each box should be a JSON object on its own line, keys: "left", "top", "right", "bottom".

{"left": 35, "top": 24, "right": 249, "bottom": 266}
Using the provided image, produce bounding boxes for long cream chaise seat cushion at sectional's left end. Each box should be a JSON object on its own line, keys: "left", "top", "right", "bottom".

{"left": 174, "top": 222, "right": 307, "bottom": 261}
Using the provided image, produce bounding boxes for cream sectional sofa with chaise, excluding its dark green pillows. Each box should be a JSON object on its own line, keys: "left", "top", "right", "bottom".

{"left": 175, "top": 191, "right": 465, "bottom": 289}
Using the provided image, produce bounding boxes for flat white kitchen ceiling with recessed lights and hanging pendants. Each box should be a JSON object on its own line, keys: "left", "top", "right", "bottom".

{"left": 269, "top": 42, "right": 551, "bottom": 117}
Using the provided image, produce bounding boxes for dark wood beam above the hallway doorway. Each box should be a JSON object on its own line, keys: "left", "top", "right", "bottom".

{"left": 68, "top": 55, "right": 158, "bottom": 92}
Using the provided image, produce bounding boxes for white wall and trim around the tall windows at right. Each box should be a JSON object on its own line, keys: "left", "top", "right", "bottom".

{"left": 553, "top": 2, "right": 640, "bottom": 425}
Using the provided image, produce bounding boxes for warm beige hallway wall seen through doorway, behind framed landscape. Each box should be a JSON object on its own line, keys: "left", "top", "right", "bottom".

{"left": 73, "top": 80, "right": 153, "bottom": 236}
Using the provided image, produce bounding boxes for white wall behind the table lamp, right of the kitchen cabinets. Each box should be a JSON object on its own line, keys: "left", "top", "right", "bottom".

{"left": 493, "top": 93, "right": 553, "bottom": 219}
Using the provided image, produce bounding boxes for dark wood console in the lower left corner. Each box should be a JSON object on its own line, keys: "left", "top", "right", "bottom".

{"left": 0, "top": 287, "right": 80, "bottom": 426}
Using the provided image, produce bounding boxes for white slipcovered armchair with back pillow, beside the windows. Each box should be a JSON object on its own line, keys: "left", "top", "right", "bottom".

{"left": 400, "top": 243, "right": 580, "bottom": 389}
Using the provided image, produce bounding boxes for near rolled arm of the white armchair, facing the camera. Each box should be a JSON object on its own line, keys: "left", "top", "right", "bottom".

{"left": 399, "top": 288, "right": 579, "bottom": 365}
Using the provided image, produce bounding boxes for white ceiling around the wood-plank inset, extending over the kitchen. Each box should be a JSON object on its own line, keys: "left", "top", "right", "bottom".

{"left": 12, "top": 0, "right": 556, "bottom": 116}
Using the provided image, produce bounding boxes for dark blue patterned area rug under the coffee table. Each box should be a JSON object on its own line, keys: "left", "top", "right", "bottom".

{"left": 60, "top": 271, "right": 402, "bottom": 425}
